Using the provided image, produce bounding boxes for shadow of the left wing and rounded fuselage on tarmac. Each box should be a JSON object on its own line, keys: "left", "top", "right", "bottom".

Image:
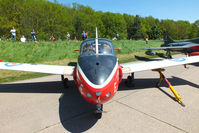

{"left": 0, "top": 81, "right": 98, "bottom": 132}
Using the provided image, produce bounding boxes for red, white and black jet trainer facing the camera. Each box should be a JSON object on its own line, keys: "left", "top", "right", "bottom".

{"left": 0, "top": 30, "right": 199, "bottom": 118}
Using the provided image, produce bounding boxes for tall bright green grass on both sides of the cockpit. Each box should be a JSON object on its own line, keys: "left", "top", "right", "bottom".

{"left": 0, "top": 40, "right": 162, "bottom": 63}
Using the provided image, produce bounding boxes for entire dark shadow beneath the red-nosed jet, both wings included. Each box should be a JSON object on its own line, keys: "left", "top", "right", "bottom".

{"left": 0, "top": 76, "right": 199, "bottom": 132}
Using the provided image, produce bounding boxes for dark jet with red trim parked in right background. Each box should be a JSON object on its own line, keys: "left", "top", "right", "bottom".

{"left": 143, "top": 33, "right": 199, "bottom": 58}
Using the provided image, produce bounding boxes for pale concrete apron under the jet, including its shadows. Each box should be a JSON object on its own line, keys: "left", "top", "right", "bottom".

{"left": 0, "top": 54, "right": 199, "bottom": 133}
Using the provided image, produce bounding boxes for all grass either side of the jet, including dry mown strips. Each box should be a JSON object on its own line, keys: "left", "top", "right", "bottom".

{"left": 0, "top": 40, "right": 163, "bottom": 83}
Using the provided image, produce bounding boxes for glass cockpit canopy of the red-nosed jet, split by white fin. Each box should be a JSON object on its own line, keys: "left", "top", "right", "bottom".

{"left": 80, "top": 38, "right": 115, "bottom": 56}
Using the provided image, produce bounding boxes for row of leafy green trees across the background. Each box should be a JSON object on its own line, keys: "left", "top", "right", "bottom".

{"left": 0, "top": 0, "right": 199, "bottom": 40}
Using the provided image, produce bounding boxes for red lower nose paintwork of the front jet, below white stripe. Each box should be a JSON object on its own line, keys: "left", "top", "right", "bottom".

{"left": 73, "top": 65, "right": 123, "bottom": 104}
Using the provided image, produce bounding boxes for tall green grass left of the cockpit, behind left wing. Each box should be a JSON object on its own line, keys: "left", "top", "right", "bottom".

{"left": 0, "top": 41, "right": 80, "bottom": 63}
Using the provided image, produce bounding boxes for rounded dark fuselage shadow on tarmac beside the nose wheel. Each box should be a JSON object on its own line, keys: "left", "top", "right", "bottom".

{"left": 59, "top": 84, "right": 98, "bottom": 133}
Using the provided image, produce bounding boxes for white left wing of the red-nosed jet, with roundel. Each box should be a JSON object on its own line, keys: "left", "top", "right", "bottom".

{"left": 0, "top": 62, "right": 74, "bottom": 75}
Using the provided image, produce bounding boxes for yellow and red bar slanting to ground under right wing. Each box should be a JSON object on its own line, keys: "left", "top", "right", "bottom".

{"left": 152, "top": 68, "right": 185, "bottom": 107}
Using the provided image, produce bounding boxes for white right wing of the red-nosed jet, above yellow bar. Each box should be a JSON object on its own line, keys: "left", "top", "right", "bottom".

{"left": 121, "top": 56, "right": 199, "bottom": 73}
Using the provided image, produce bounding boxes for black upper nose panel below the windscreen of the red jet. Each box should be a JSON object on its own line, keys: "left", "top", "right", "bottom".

{"left": 78, "top": 55, "right": 117, "bottom": 85}
